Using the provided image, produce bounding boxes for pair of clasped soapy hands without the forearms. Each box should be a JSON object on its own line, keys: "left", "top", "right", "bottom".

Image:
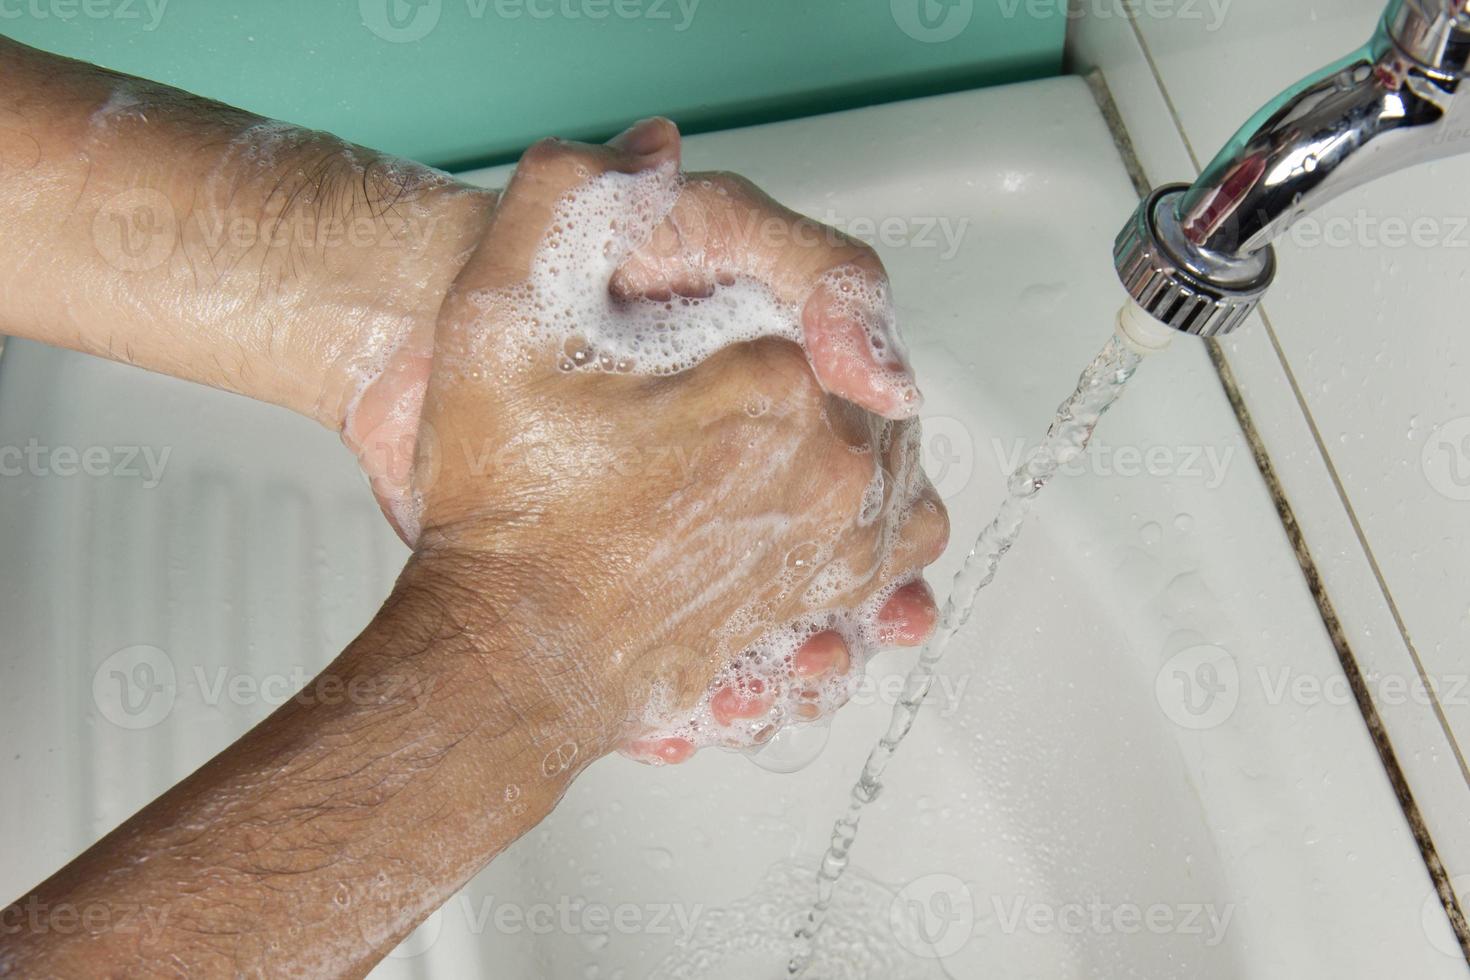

{"left": 345, "top": 120, "right": 947, "bottom": 761}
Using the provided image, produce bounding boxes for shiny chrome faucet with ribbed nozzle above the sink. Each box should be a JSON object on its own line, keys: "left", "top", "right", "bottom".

{"left": 1113, "top": 0, "right": 1470, "bottom": 336}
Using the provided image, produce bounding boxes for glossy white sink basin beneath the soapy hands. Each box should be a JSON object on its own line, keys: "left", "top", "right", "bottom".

{"left": 0, "top": 79, "right": 1446, "bottom": 980}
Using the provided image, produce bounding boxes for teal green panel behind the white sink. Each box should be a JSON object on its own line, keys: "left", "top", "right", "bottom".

{"left": 0, "top": 0, "right": 1066, "bottom": 166}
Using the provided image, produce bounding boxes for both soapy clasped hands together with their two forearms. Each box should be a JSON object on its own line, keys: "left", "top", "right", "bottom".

{"left": 0, "top": 45, "right": 945, "bottom": 976}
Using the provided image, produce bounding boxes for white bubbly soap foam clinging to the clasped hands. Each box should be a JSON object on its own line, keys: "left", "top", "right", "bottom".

{"left": 446, "top": 165, "right": 925, "bottom": 763}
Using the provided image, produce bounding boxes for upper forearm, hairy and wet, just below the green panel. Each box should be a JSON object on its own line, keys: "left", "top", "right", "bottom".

{"left": 0, "top": 38, "right": 492, "bottom": 429}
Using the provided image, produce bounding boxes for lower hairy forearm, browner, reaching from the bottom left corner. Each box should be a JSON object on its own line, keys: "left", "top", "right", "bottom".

{"left": 0, "top": 557, "right": 610, "bottom": 977}
